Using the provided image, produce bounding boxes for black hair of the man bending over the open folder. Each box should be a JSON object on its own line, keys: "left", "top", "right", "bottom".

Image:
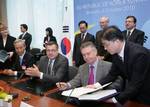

{"left": 101, "top": 26, "right": 124, "bottom": 41}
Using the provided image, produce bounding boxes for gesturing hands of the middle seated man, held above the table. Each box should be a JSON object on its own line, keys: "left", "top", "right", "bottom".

{"left": 25, "top": 65, "right": 41, "bottom": 77}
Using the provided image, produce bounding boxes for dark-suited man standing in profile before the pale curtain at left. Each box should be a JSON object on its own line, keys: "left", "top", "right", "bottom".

{"left": 19, "top": 24, "right": 32, "bottom": 52}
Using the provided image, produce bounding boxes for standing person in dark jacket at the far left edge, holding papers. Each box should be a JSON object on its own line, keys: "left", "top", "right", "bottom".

{"left": 0, "top": 25, "right": 16, "bottom": 69}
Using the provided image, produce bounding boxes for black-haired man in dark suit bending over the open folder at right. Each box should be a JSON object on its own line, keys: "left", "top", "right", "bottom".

{"left": 89, "top": 26, "right": 150, "bottom": 105}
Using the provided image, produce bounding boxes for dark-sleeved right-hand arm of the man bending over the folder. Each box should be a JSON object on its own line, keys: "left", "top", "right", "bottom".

{"left": 116, "top": 55, "right": 149, "bottom": 103}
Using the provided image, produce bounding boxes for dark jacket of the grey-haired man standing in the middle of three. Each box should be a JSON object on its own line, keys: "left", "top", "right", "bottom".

{"left": 95, "top": 30, "right": 112, "bottom": 61}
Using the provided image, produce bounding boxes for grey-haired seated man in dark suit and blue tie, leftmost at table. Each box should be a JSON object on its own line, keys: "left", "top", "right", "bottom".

{"left": 3, "top": 39, "right": 34, "bottom": 75}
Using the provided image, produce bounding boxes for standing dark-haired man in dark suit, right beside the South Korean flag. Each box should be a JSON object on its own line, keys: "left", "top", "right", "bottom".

{"left": 73, "top": 21, "right": 95, "bottom": 67}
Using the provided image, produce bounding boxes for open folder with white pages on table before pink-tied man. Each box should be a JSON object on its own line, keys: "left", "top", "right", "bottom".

{"left": 62, "top": 83, "right": 117, "bottom": 100}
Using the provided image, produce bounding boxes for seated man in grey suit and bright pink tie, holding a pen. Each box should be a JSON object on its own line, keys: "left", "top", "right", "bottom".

{"left": 56, "top": 42, "right": 121, "bottom": 90}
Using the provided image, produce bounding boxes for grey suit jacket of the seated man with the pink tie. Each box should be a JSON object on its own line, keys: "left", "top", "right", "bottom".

{"left": 69, "top": 60, "right": 123, "bottom": 90}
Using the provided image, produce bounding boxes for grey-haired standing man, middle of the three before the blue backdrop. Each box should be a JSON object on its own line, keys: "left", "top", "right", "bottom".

{"left": 95, "top": 16, "right": 111, "bottom": 61}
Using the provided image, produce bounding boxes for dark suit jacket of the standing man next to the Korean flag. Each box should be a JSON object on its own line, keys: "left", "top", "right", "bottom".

{"left": 73, "top": 33, "right": 95, "bottom": 67}
